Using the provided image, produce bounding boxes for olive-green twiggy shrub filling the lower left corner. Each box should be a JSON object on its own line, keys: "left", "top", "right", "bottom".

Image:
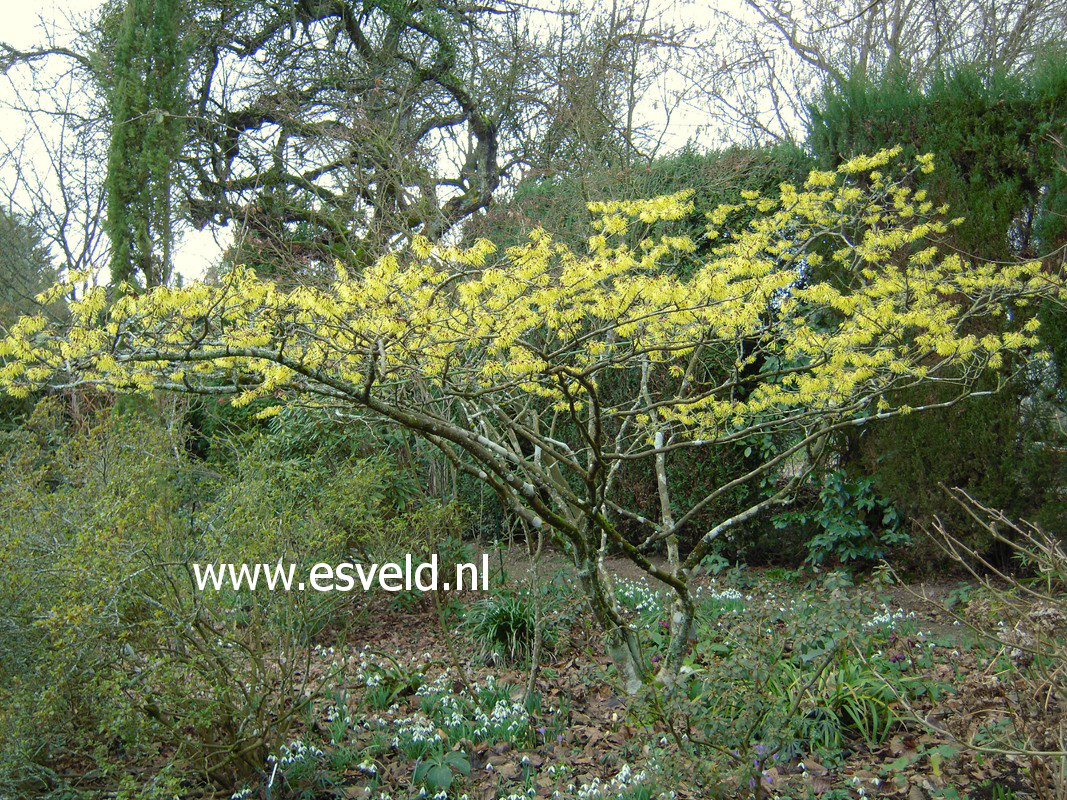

{"left": 0, "top": 403, "right": 266, "bottom": 780}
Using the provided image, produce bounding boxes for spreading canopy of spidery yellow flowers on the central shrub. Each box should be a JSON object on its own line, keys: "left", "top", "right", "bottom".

{"left": 0, "top": 148, "right": 1064, "bottom": 438}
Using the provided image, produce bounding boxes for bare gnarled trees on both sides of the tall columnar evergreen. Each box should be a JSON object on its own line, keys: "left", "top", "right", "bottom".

{"left": 3, "top": 0, "right": 682, "bottom": 278}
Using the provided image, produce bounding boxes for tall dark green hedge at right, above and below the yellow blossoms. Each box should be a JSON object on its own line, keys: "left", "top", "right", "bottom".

{"left": 809, "top": 52, "right": 1067, "bottom": 550}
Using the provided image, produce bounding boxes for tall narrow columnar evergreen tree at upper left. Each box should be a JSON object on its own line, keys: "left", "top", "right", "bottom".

{"left": 107, "top": 0, "right": 188, "bottom": 286}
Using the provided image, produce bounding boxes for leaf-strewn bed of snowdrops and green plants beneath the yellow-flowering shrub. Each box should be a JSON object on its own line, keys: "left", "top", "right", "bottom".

{"left": 10, "top": 522, "right": 1061, "bottom": 798}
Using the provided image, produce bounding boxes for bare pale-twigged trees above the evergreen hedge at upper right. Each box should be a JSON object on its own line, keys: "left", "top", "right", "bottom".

{"left": 691, "top": 0, "right": 1067, "bottom": 141}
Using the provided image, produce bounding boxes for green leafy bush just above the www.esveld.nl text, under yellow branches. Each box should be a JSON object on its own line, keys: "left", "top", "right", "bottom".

{"left": 196, "top": 407, "right": 465, "bottom": 570}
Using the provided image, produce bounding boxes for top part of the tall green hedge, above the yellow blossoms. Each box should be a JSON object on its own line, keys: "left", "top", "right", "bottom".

{"left": 809, "top": 55, "right": 1067, "bottom": 259}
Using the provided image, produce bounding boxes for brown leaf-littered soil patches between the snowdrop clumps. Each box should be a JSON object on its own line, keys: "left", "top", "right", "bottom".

{"left": 296, "top": 544, "right": 1058, "bottom": 800}
